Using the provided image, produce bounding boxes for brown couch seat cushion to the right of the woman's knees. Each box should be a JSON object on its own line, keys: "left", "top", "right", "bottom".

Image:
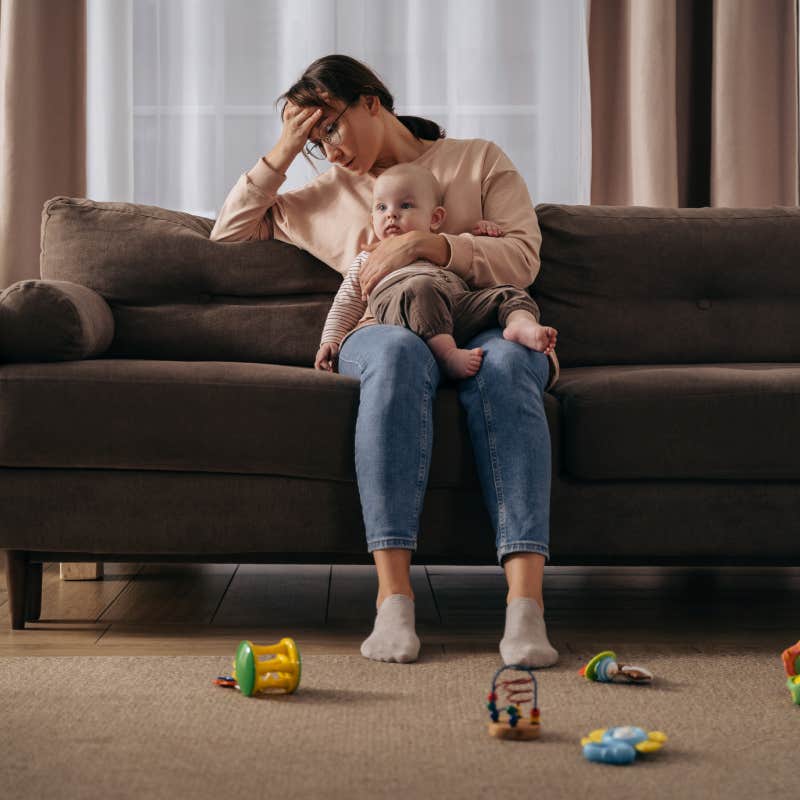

{"left": 553, "top": 363, "right": 800, "bottom": 480}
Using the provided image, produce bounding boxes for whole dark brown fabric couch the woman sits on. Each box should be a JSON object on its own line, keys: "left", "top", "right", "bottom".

{"left": 0, "top": 197, "right": 800, "bottom": 628}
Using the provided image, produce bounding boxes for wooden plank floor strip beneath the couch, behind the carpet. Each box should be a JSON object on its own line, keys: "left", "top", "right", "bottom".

{"left": 0, "top": 563, "right": 800, "bottom": 658}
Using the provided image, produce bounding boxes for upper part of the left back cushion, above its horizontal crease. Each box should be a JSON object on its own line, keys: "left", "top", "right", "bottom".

{"left": 40, "top": 197, "right": 342, "bottom": 304}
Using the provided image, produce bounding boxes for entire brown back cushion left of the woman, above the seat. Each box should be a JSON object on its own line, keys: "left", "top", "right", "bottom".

{"left": 40, "top": 197, "right": 341, "bottom": 366}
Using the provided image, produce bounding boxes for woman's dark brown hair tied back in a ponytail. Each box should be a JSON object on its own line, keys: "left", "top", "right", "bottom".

{"left": 275, "top": 54, "right": 447, "bottom": 169}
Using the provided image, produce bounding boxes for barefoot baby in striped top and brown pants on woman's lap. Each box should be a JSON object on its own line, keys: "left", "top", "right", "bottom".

{"left": 314, "top": 164, "right": 557, "bottom": 379}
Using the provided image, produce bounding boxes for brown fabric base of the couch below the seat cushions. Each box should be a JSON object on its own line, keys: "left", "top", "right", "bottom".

{"left": 0, "top": 468, "right": 800, "bottom": 565}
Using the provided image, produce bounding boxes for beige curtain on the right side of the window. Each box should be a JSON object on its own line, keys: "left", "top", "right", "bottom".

{"left": 589, "top": 0, "right": 798, "bottom": 206}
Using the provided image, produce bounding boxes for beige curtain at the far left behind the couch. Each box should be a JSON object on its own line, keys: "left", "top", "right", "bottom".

{"left": 0, "top": 0, "right": 86, "bottom": 288}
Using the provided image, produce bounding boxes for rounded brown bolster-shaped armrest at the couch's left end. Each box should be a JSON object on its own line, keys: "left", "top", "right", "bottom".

{"left": 0, "top": 280, "right": 114, "bottom": 362}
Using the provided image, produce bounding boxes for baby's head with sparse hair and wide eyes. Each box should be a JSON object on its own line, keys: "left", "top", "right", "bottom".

{"left": 372, "top": 164, "right": 447, "bottom": 239}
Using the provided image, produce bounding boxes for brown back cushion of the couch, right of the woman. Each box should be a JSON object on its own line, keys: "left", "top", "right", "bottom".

{"left": 531, "top": 205, "right": 800, "bottom": 366}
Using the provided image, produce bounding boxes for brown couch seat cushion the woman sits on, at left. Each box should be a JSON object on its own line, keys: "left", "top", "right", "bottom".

{"left": 0, "top": 359, "right": 558, "bottom": 492}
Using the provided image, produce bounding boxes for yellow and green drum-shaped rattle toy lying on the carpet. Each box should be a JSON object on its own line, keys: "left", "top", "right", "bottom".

{"left": 214, "top": 637, "right": 303, "bottom": 697}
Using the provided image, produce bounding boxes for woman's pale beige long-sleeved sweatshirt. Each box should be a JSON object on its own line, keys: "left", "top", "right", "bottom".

{"left": 210, "top": 139, "right": 542, "bottom": 343}
